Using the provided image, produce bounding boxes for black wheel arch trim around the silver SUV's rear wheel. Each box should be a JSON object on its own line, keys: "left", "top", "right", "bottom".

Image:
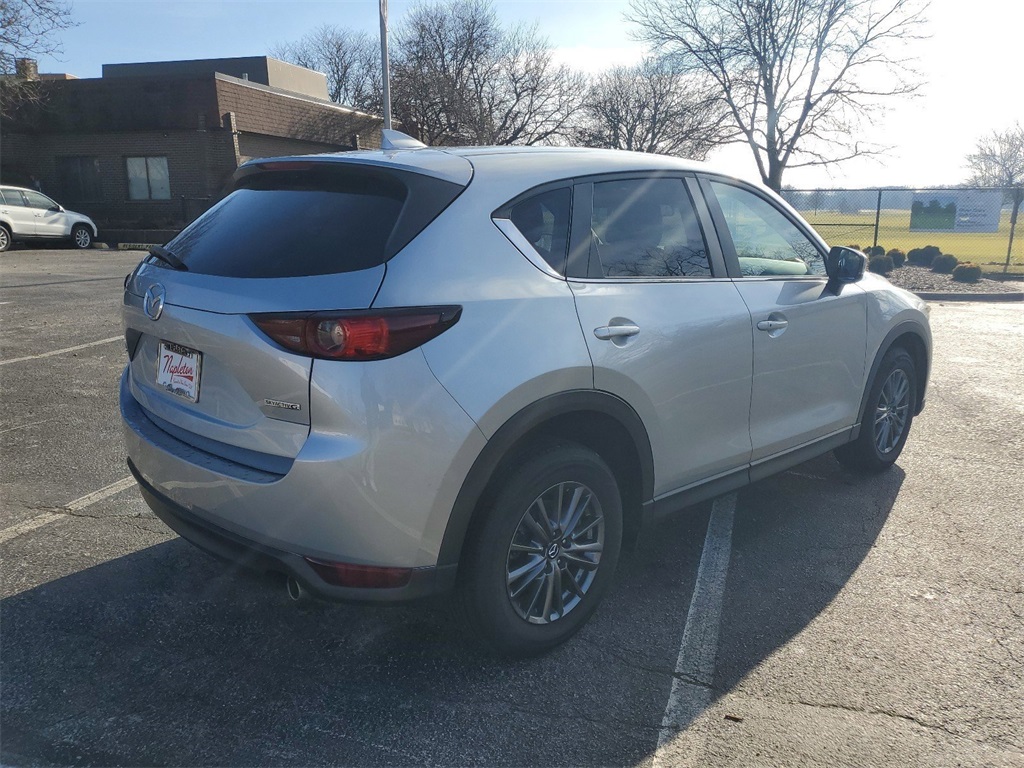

{"left": 437, "top": 390, "right": 654, "bottom": 565}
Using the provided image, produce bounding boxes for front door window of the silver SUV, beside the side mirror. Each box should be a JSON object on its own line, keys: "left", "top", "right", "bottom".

{"left": 711, "top": 181, "right": 825, "bottom": 278}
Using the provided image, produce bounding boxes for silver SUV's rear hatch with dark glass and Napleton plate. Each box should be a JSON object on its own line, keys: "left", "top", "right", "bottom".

{"left": 124, "top": 156, "right": 468, "bottom": 466}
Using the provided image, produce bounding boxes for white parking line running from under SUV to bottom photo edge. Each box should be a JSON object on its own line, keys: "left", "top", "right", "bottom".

{"left": 653, "top": 494, "right": 736, "bottom": 768}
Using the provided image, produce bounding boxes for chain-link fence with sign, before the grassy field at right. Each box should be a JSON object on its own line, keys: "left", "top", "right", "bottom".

{"left": 782, "top": 187, "right": 1024, "bottom": 272}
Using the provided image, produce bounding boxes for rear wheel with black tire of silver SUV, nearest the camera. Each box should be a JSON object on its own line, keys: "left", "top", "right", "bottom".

{"left": 456, "top": 442, "right": 623, "bottom": 656}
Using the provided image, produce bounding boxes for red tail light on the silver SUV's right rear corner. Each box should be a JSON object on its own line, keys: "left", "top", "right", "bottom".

{"left": 249, "top": 306, "right": 462, "bottom": 360}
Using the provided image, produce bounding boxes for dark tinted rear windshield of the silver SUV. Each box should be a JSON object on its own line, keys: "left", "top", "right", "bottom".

{"left": 167, "top": 168, "right": 461, "bottom": 278}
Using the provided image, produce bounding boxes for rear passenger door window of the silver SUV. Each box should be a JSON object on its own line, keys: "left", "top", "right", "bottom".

{"left": 591, "top": 178, "right": 711, "bottom": 278}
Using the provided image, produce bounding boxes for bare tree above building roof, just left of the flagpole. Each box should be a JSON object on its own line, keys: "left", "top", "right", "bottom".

{"left": 270, "top": 25, "right": 382, "bottom": 113}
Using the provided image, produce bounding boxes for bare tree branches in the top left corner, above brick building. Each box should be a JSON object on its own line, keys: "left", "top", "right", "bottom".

{"left": 0, "top": 0, "right": 76, "bottom": 115}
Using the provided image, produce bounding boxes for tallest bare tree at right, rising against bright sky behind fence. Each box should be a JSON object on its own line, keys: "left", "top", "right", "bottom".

{"left": 630, "top": 0, "right": 924, "bottom": 191}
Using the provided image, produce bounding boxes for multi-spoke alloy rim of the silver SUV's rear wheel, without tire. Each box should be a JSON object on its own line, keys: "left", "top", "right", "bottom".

{"left": 505, "top": 481, "right": 604, "bottom": 624}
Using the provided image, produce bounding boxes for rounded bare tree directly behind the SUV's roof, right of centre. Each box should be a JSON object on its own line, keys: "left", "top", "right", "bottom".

{"left": 577, "top": 58, "right": 727, "bottom": 160}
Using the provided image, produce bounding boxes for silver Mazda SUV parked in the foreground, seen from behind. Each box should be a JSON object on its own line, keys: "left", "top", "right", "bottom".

{"left": 121, "top": 138, "right": 931, "bottom": 654}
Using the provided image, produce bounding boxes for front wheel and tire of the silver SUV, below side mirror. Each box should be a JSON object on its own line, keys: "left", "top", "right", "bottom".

{"left": 835, "top": 347, "right": 918, "bottom": 472}
